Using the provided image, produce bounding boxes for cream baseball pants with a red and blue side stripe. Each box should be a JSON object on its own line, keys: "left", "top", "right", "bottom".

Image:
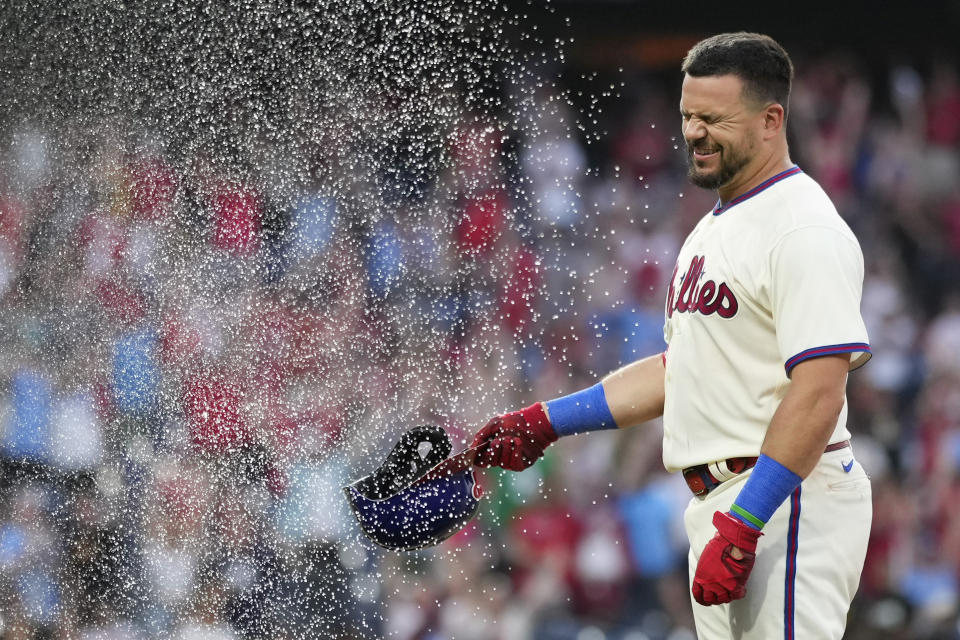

{"left": 684, "top": 447, "right": 873, "bottom": 640}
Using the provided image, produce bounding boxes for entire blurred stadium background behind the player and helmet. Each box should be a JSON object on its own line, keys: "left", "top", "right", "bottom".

{"left": 0, "top": 0, "right": 960, "bottom": 640}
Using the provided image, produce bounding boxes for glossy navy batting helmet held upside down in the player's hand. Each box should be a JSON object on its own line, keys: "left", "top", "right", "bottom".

{"left": 343, "top": 426, "right": 482, "bottom": 551}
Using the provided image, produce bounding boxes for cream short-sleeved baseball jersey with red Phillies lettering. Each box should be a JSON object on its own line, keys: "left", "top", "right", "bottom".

{"left": 663, "top": 167, "right": 870, "bottom": 471}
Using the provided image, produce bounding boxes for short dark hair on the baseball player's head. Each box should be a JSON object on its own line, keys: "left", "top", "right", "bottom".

{"left": 680, "top": 31, "right": 793, "bottom": 111}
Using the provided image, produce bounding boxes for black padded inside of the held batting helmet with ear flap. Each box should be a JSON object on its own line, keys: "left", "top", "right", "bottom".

{"left": 353, "top": 425, "right": 453, "bottom": 500}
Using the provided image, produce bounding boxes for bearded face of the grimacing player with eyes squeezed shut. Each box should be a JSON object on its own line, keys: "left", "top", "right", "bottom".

{"left": 680, "top": 75, "right": 762, "bottom": 189}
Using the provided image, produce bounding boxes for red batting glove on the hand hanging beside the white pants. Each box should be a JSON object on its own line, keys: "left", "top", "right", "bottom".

{"left": 693, "top": 511, "right": 763, "bottom": 605}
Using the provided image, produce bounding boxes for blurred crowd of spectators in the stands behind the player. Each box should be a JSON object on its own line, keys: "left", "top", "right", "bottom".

{"left": 0, "top": 43, "right": 960, "bottom": 640}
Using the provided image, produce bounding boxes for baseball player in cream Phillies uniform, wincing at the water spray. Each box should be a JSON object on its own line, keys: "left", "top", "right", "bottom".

{"left": 473, "top": 33, "right": 871, "bottom": 640}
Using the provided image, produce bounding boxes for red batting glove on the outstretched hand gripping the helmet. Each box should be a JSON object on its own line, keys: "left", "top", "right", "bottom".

{"left": 470, "top": 402, "right": 557, "bottom": 471}
